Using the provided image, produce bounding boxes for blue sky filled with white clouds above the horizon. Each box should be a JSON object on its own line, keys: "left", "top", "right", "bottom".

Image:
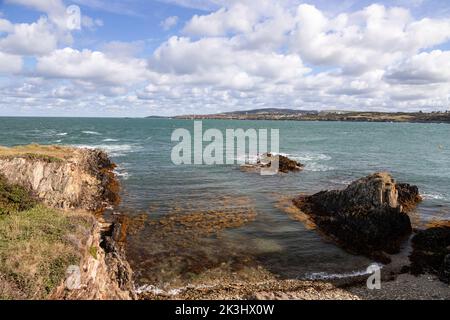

{"left": 0, "top": 0, "right": 450, "bottom": 117}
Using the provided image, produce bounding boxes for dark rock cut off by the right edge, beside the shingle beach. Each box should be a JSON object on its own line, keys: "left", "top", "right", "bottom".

{"left": 410, "top": 226, "right": 450, "bottom": 283}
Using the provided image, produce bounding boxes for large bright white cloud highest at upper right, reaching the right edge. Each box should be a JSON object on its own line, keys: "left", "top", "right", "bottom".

{"left": 291, "top": 5, "right": 450, "bottom": 74}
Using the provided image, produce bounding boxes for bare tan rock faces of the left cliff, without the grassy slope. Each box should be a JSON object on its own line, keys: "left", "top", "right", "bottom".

{"left": 0, "top": 145, "right": 135, "bottom": 300}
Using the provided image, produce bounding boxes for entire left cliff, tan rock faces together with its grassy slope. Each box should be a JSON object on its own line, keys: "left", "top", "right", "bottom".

{"left": 0, "top": 145, "right": 134, "bottom": 299}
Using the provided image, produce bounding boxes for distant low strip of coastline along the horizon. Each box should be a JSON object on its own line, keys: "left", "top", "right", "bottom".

{"left": 172, "top": 109, "right": 450, "bottom": 123}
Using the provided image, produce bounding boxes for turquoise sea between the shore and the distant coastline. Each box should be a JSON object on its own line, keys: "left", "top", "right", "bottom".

{"left": 0, "top": 118, "right": 450, "bottom": 283}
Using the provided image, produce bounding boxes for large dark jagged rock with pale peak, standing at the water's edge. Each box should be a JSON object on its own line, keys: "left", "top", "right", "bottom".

{"left": 294, "top": 173, "right": 419, "bottom": 262}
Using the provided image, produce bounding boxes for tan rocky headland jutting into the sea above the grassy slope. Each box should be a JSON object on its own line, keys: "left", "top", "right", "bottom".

{"left": 0, "top": 147, "right": 119, "bottom": 211}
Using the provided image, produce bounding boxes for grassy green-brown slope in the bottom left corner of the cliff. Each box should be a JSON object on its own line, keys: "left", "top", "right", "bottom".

{"left": 0, "top": 178, "right": 92, "bottom": 299}
